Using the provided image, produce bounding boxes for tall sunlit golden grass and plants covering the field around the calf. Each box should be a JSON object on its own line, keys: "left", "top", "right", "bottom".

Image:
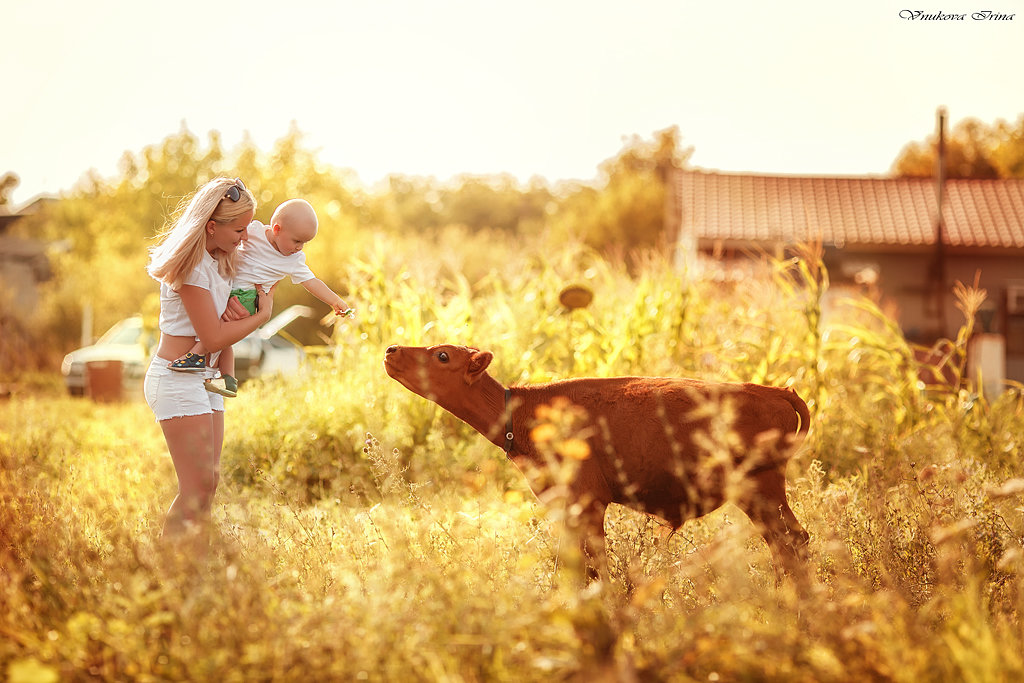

{"left": 0, "top": 231, "right": 1024, "bottom": 681}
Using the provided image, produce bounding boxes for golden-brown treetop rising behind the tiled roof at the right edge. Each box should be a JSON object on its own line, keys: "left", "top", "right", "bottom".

{"left": 892, "top": 116, "right": 1024, "bottom": 179}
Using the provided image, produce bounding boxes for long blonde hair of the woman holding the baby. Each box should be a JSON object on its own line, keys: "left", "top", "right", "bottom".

{"left": 146, "top": 177, "right": 256, "bottom": 291}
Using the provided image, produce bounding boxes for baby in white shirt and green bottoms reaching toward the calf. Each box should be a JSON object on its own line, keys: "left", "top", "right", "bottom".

{"left": 168, "top": 200, "right": 354, "bottom": 397}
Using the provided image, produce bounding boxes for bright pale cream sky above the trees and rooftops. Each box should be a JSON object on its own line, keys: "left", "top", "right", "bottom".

{"left": 0, "top": 0, "right": 1024, "bottom": 204}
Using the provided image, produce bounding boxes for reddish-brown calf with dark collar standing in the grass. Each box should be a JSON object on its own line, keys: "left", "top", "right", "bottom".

{"left": 384, "top": 344, "right": 809, "bottom": 577}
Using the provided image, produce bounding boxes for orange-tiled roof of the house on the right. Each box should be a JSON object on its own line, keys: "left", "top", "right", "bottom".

{"left": 676, "top": 171, "right": 1024, "bottom": 248}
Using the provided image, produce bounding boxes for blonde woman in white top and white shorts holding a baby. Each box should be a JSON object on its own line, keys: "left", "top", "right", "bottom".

{"left": 144, "top": 178, "right": 273, "bottom": 544}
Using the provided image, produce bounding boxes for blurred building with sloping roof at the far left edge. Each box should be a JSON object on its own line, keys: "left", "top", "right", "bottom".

{"left": 0, "top": 197, "right": 55, "bottom": 315}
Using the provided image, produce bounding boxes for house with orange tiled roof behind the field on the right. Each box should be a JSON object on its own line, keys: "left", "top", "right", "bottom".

{"left": 670, "top": 170, "right": 1024, "bottom": 381}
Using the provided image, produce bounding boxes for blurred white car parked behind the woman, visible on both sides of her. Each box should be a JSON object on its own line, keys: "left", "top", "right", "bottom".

{"left": 60, "top": 305, "right": 313, "bottom": 396}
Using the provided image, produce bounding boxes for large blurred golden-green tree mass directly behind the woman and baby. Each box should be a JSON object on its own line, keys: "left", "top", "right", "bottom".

{"left": 13, "top": 126, "right": 370, "bottom": 360}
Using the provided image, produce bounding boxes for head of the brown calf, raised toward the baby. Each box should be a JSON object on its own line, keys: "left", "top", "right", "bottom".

{"left": 384, "top": 344, "right": 494, "bottom": 410}
